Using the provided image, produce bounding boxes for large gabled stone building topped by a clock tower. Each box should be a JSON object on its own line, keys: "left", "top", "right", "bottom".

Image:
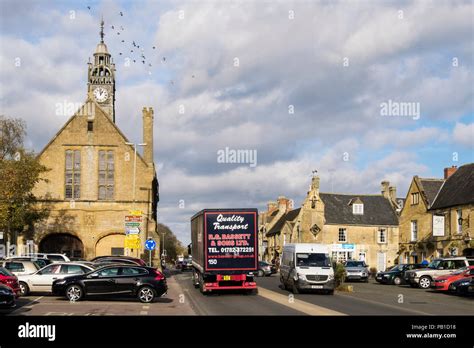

{"left": 22, "top": 21, "right": 158, "bottom": 258}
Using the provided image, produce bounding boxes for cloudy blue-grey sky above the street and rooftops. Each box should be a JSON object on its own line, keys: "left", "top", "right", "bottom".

{"left": 0, "top": 0, "right": 474, "bottom": 243}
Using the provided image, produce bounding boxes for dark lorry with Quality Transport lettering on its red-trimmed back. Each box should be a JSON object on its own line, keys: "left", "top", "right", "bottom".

{"left": 191, "top": 209, "right": 258, "bottom": 293}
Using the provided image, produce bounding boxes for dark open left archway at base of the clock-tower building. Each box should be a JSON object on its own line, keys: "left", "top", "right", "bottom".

{"left": 39, "top": 233, "right": 84, "bottom": 257}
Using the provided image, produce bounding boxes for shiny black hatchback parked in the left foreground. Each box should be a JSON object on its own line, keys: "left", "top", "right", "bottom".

{"left": 52, "top": 265, "right": 168, "bottom": 303}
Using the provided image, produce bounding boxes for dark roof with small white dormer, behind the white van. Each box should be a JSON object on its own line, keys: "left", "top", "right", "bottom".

{"left": 319, "top": 193, "right": 398, "bottom": 226}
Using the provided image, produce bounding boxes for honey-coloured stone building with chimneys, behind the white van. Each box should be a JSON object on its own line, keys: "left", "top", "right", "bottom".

{"left": 260, "top": 176, "right": 399, "bottom": 270}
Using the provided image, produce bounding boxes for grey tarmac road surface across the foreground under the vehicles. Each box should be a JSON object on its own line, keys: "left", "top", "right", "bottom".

{"left": 0, "top": 270, "right": 474, "bottom": 316}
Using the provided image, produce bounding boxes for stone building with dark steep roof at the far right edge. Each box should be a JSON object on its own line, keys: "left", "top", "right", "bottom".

{"left": 400, "top": 163, "right": 474, "bottom": 262}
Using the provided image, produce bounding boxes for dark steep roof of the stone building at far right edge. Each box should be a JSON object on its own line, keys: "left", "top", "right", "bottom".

{"left": 430, "top": 163, "right": 474, "bottom": 210}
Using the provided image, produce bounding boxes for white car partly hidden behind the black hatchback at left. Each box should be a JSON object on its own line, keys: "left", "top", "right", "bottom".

{"left": 18, "top": 262, "right": 95, "bottom": 296}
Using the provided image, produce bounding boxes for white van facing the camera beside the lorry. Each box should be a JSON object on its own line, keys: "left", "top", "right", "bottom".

{"left": 280, "top": 243, "right": 335, "bottom": 295}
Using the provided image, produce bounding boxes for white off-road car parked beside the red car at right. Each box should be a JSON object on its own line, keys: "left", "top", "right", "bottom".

{"left": 405, "top": 257, "right": 469, "bottom": 289}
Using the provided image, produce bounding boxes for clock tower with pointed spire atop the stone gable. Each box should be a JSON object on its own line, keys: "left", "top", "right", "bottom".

{"left": 87, "top": 19, "right": 115, "bottom": 122}
